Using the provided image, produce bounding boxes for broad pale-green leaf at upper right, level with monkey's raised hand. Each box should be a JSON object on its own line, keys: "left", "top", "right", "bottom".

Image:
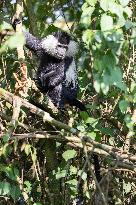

{"left": 100, "top": 14, "right": 113, "bottom": 31}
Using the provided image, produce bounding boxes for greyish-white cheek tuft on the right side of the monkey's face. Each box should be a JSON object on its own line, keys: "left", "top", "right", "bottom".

{"left": 66, "top": 40, "right": 78, "bottom": 57}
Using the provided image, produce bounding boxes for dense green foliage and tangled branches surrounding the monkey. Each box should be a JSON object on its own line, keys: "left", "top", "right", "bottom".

{"left": 0, "top": 0, "right": 136, "bottom": 205}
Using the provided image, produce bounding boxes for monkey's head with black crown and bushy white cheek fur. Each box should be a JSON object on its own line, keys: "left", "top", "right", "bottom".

{"left": 41, "top": 31, "right": 75, "bottom": 59}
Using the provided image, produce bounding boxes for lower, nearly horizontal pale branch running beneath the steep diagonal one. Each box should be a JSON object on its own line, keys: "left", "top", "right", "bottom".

{"left": 8, "top": 131, "right": 136, "bottom": 170}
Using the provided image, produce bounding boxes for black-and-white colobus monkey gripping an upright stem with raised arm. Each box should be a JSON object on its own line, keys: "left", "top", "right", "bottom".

{"left": 13, "top": 19, "right": 86, "bottom": 111}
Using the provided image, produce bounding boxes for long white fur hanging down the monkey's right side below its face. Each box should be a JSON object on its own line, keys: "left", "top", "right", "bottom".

{"left": 66, "top": 58, "right": 77, "bottom": 87}
